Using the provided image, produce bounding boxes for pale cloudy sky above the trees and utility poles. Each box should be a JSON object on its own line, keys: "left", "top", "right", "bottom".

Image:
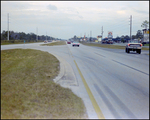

{"left": 1, "top": 1, "right": 149, "bottom": 39}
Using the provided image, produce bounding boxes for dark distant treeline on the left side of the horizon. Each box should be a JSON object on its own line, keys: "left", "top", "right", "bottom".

{"left": 1, "top": 30, "right": 58, "bottom": 42}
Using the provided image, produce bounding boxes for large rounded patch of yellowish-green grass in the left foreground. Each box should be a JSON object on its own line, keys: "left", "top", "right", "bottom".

{"left": 1, "top": 49, "right": 87, "bottom": 119}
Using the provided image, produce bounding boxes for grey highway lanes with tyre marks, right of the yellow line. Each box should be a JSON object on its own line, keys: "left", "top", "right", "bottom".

{"left": 68, "top": 45, "right": 149, "bottom": 118}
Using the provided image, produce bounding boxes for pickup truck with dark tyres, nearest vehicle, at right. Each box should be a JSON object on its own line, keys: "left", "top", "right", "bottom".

{"left": 125, "top": 40, "right": 142, "bottom": 54}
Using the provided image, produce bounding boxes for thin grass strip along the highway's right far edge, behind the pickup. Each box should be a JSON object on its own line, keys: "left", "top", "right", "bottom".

{"left": 81, "top": 42, "right": 149, "bottom": 50}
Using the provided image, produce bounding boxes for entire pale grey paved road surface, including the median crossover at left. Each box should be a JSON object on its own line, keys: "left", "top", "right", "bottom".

{"left": 1, "top": 43, "right": 149, "bottom": 119}
